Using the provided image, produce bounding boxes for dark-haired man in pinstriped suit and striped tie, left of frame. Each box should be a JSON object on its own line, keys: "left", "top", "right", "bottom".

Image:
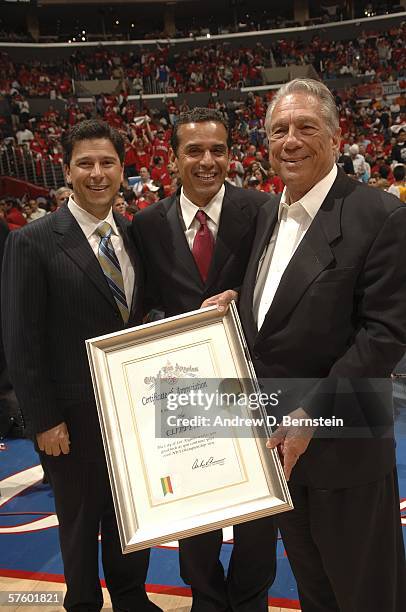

{"left": 2, "top": 120, "right": 159, "bottom": 612}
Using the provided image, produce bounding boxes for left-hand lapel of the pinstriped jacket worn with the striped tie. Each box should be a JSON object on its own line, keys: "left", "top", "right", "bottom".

{"left": 52, "top": 206, "right": 119, "bottom": 312}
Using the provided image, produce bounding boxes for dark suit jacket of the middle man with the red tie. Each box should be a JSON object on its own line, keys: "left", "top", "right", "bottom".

{"left": 132, "top": 183, "right": 270, "bottom": 317}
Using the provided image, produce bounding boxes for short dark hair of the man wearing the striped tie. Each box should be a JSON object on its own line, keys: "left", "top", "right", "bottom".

{"left": 62, "top": 119, "right": 125, "bottom": 166}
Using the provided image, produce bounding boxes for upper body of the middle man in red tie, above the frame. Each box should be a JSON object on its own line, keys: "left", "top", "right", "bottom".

{"left": 133, "top": 108, "right": 269, "bottom": 317}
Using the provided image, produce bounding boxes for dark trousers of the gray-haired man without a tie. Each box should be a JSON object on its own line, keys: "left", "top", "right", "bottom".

{"left": 277, "top": 471, "right": 406, "bottom": 612}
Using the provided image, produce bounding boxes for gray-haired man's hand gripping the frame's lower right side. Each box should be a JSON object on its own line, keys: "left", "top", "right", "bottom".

{"left": 266, "top": 408, "right": 315, "bottom": 480}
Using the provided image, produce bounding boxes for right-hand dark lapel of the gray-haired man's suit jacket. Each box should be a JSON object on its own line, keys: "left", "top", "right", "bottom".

{"left": 258, "top": 173, "right": 348, "bottom": 340}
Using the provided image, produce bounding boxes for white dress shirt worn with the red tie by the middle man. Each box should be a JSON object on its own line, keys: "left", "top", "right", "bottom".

{"left": 180, "top": 185, "right": 225, "bottom": 250}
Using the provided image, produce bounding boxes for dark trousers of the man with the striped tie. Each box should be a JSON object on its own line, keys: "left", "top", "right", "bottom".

{"left": 41, "top": 453, "right": 160, "bottom": 612}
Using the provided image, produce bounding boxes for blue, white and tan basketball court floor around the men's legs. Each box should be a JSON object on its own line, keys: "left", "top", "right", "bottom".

{"left": 0, "top": 407, "right": 406, "bottom": 612}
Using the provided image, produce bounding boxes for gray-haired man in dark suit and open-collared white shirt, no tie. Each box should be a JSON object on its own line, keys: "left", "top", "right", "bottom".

{"left": 230, "top": 79, "right": 406, "bottom": 612}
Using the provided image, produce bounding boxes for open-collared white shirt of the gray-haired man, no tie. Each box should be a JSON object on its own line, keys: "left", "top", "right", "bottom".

{"left": 253, "top": 164, "right": 337, "bottom": 329}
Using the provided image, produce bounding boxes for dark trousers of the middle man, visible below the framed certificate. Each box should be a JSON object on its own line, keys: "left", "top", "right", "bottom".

{"left": 179, "top": 517, "right": 276, "bottom": 612}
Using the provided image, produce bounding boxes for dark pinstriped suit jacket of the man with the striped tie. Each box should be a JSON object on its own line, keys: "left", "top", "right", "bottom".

{"left": 2, "top": 206, "right": 143, "bottom": 458}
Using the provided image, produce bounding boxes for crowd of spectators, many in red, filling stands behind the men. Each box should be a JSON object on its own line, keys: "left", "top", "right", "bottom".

{"left": 0, "top": 23, "right": 406, "bottom": 225}
